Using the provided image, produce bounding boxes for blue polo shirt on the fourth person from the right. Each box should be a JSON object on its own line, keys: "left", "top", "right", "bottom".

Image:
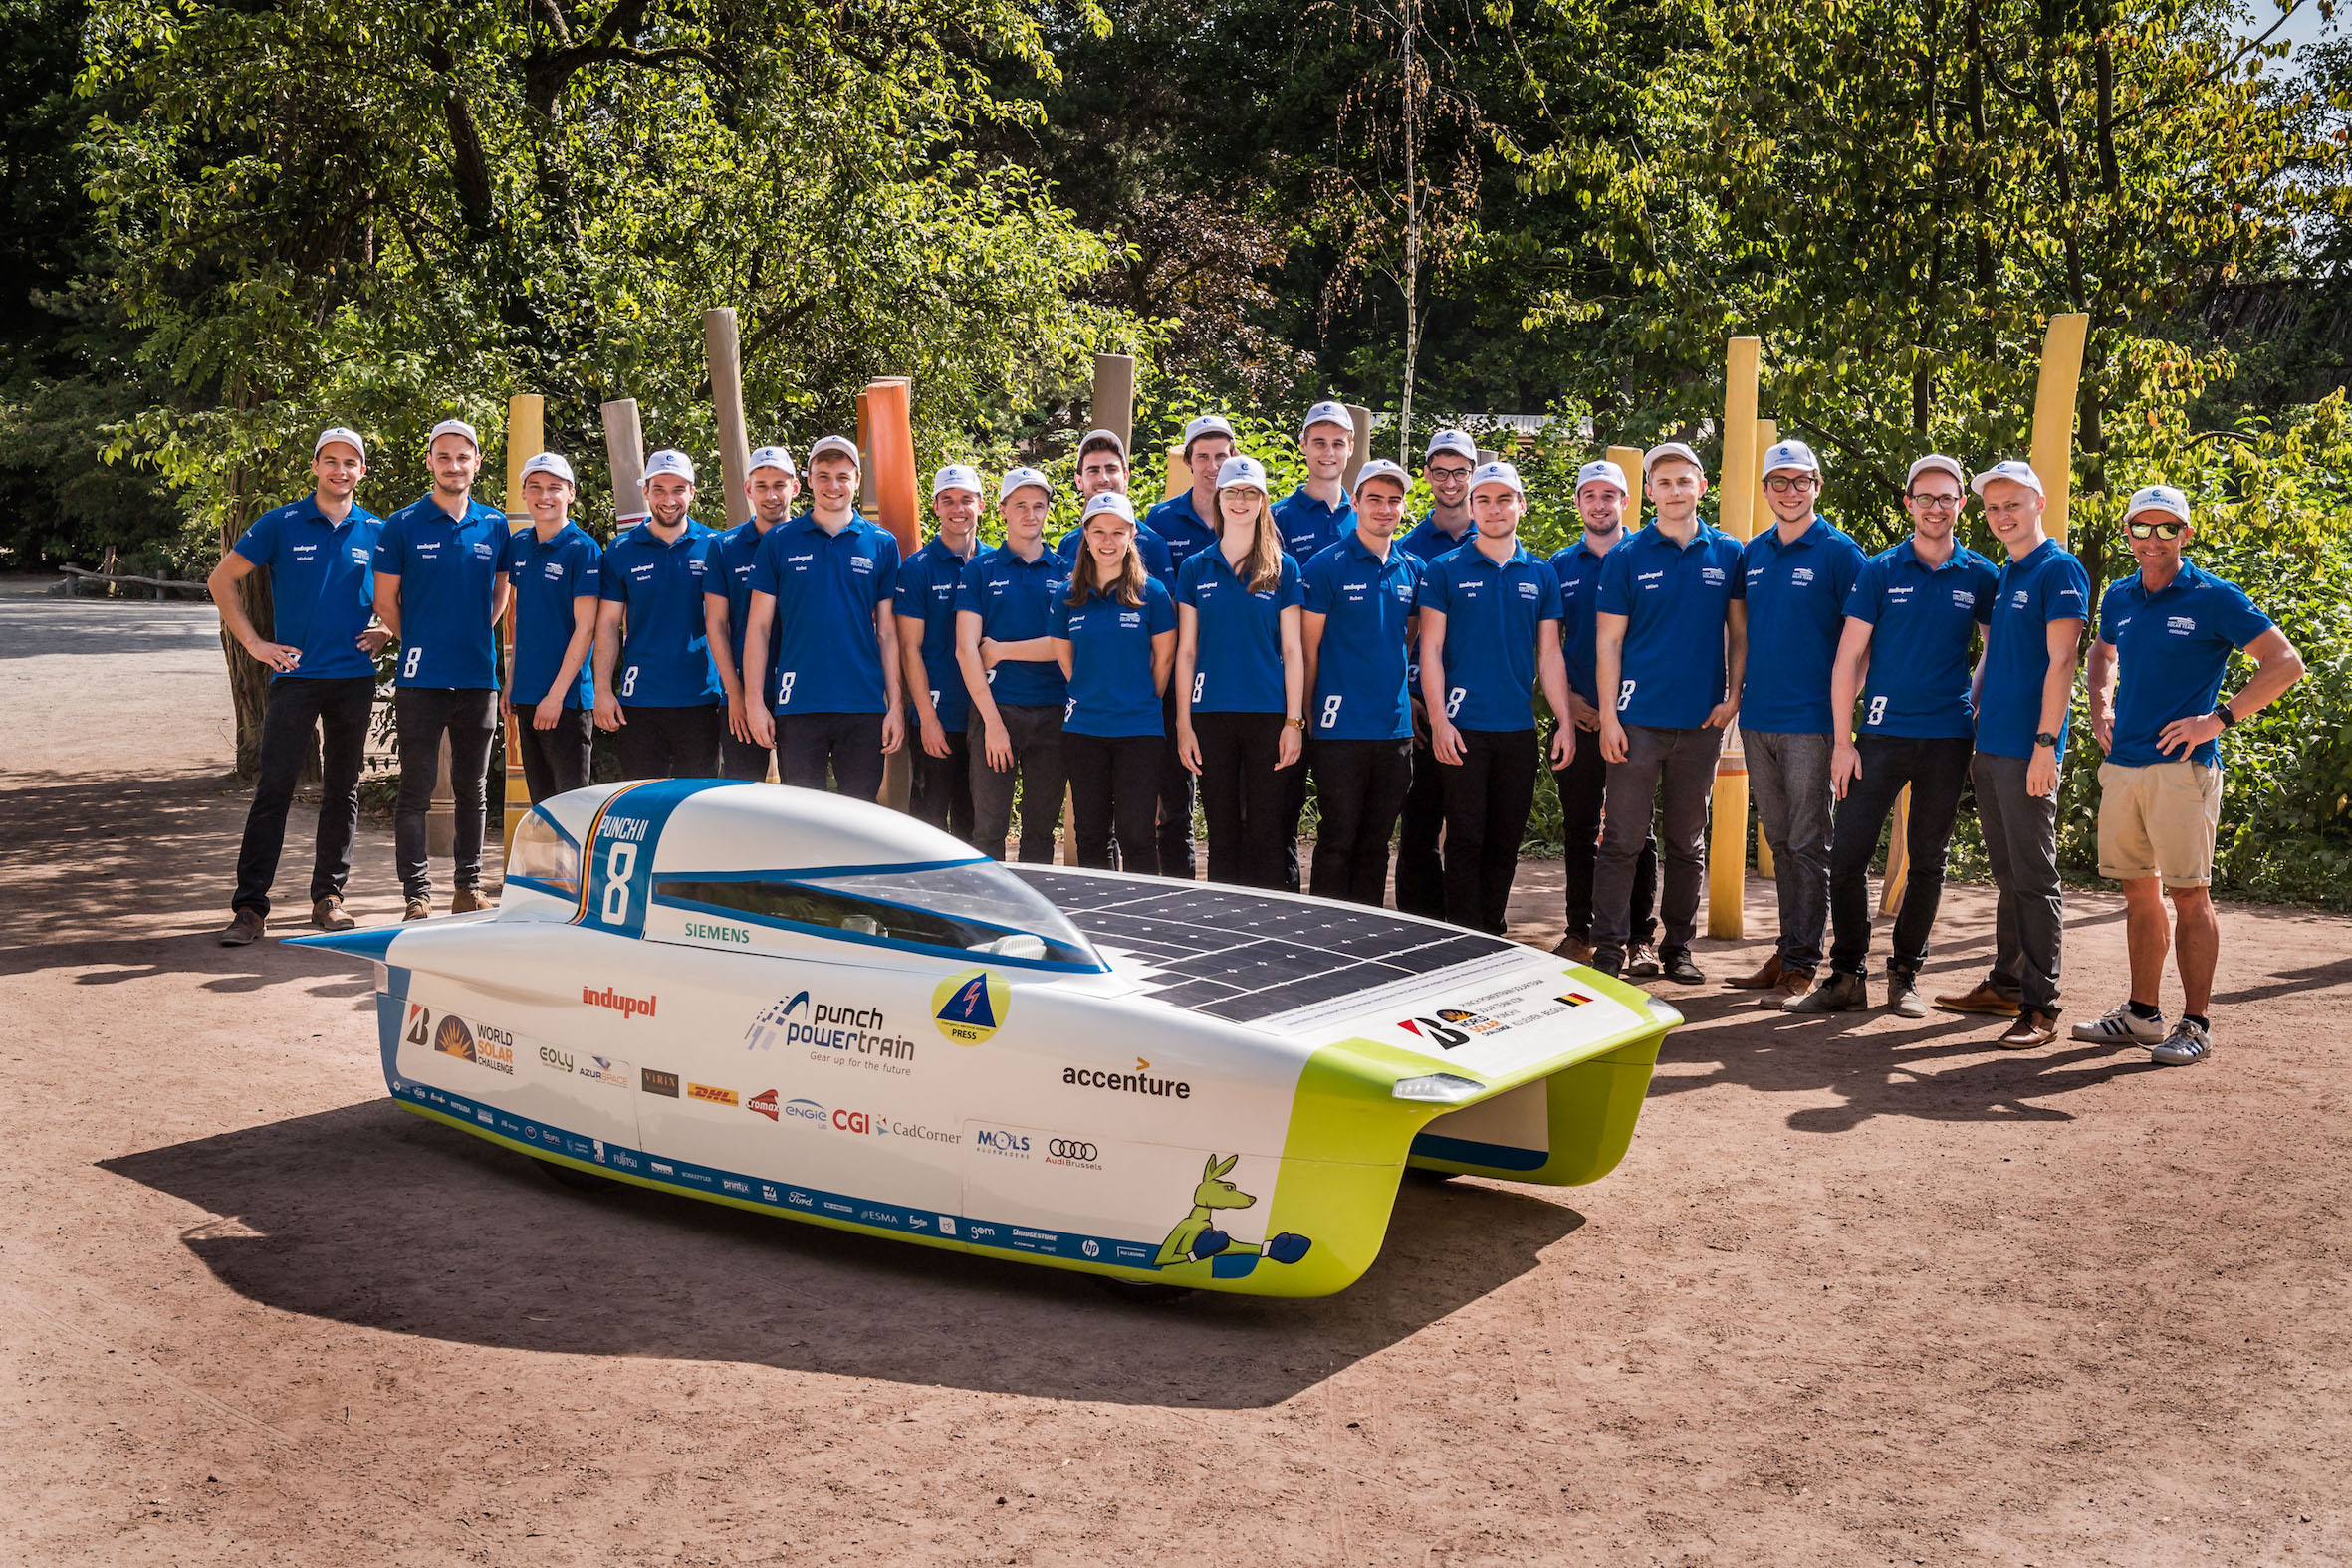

{"left": 1731, "top": 513, "right": 1863, "bottom": 736}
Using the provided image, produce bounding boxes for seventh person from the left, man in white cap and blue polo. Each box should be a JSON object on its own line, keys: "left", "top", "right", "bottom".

{"left": 896, "top": 463, "right": 981, "bottom": 844}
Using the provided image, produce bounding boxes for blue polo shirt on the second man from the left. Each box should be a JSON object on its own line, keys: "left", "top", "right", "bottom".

{"left": 376, "top": 496, "right": 506, "bottom": 691}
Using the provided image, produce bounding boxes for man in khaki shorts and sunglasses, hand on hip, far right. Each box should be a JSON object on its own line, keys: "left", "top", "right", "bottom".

{"left": 2074, "top": 484, "right": 2302, "bottom": 1067}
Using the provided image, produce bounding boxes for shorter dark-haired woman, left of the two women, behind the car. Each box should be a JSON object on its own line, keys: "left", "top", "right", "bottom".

{"left": 1054, "top": 494, "right": 1176, "bottom": 877}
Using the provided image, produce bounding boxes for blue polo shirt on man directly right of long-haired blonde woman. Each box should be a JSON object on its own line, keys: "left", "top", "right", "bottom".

{"left": 1298, "top": 529, "right": 1428, "bottom": 741}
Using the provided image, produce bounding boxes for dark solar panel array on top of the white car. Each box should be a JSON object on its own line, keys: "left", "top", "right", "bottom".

{"left": 1005, "top": 865, "right": 1513, "bottom": 1022}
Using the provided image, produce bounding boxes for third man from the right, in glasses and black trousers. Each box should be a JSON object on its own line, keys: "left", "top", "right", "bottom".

{"left": 1787, "top": 454, "right": 1999, "bottom": 1017}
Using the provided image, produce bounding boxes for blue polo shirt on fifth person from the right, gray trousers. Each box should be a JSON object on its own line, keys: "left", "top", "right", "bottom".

{"left": 1592, "top": 520, "right": 1741, "bottom": 729}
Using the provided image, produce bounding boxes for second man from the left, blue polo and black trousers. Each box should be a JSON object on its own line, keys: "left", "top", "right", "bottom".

{"left": 376, "top": 418, "right": 511, "bottom": 919}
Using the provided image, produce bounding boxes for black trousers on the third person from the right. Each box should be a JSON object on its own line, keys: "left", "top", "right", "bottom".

{"left": 1830, "top": 736, "right": 1976, "bottom": 976}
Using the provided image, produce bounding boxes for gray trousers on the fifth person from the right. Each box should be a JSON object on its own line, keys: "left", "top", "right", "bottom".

{"left": 1592, "top": 724, "right": 1724, "bottom": 957}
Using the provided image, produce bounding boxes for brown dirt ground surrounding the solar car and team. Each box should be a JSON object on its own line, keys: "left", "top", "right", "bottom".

{"left": 0, "top": 583, "right": 2352, "bottom": 1568}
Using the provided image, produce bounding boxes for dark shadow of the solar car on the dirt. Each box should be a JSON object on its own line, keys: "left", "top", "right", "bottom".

{"left": 99, "top": 1100, "right": 1583, "bottom": 1408}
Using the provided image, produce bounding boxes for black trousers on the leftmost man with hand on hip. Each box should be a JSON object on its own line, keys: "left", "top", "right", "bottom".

{"left": 228, "top": 675, "right": 375, "bottom": 915}
